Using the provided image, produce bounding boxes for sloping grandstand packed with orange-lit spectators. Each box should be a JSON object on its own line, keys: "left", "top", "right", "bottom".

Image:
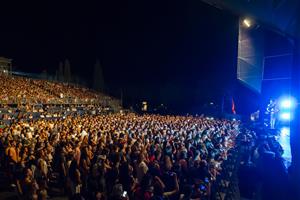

{"left": 0, "top": 73, "right": 121, "bottom": 122}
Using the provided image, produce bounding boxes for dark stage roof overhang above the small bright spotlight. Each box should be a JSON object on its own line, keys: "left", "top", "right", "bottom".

{"left": 202, "top": 0, "right": 300, "bottom": 37}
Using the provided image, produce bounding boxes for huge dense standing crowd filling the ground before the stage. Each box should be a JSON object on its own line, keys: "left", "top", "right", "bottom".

{"left": 0, "top": 113, "right": 239, "bottom": 200}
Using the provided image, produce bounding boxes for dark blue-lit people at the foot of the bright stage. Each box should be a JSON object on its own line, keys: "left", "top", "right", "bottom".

{"left": 238, "top": 128, "right": 292, "bottom": 200}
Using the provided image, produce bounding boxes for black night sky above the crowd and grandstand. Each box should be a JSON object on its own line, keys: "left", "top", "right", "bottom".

{"left": 0, "top": 0, "right": 238, "bottom": 111}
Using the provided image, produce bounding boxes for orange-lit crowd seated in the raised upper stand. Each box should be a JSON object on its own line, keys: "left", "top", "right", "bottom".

{"left": 0, "top": 73, "right": 112, "bottom": 104}
